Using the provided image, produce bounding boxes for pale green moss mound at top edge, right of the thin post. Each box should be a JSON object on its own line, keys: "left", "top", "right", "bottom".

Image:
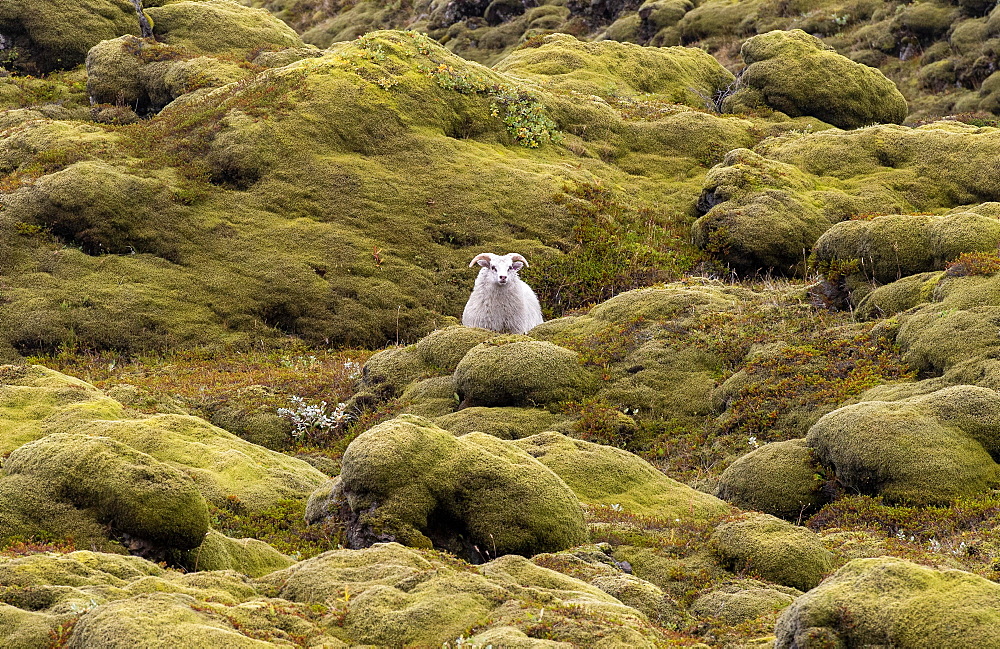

{"left": 146, "top": 0, "right": 303, "bottom": 56}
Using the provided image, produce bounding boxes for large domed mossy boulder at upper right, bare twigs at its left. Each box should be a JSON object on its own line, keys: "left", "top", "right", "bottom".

{"left": 723, "top": 29, "right": 907, "bottom": 128}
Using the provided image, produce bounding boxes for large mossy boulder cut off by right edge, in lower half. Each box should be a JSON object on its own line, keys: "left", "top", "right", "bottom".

{"left": 806, "top": 385, "right": 1000, "bottom": 504}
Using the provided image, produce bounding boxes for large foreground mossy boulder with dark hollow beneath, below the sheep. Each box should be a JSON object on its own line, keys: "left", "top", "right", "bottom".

{"left": 308, "top": 415, "right": 587, "bottom": 561}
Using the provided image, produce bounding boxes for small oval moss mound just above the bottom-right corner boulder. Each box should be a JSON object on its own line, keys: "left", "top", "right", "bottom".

{"left": 712, "top": 514, "right": 833, "bottom": 591}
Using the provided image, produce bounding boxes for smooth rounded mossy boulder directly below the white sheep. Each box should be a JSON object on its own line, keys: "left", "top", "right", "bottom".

{"left": 455, "top": 337, "right": 596, "bottom": 406}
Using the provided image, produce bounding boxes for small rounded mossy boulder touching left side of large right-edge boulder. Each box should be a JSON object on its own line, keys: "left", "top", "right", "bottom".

{"left": 716, "top": 439, "right": 827, "bottom": 521}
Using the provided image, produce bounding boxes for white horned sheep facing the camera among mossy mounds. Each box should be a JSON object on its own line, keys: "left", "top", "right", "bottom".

{"left": 462, "top": 252, "right": 542, "bottom": 334}
